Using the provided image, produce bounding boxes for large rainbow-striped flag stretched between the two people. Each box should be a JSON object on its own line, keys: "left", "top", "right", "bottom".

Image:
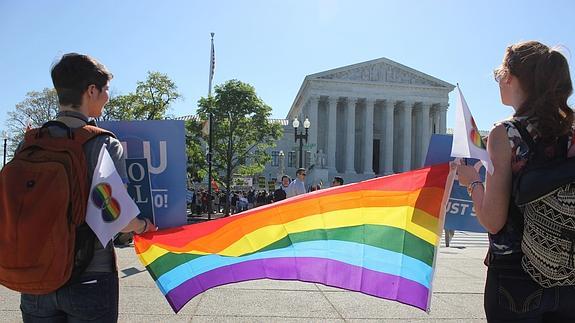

{"left": 135, "top": 164, "right": 452, "bottom": 312}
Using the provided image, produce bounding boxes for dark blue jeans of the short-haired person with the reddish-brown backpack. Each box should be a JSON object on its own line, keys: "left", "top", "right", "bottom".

{"left": 20, "top": 272, "right": 119, "bottom": 323}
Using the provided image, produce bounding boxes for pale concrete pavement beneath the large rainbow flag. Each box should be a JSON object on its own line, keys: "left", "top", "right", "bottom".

{"left": 0, "top": 232, "right": 487, "bottom": 322}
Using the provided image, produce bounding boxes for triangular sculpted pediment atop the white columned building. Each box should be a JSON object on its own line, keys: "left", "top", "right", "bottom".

{"left": 308, "top": 58, "right": 453, "bottom": 89}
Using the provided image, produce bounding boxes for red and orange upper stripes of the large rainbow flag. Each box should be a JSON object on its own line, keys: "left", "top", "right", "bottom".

{"left": 135, "top": 164, "right": 449, "bottom": 252}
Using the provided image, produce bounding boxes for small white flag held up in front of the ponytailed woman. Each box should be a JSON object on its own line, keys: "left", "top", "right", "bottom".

{"left": 451, "top": 85, "right": 493, "bottom": 175}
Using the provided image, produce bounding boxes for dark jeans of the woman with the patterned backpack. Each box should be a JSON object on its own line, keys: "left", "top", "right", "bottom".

{"left": 484, "top": 254, "right": 575, "bottom": 323}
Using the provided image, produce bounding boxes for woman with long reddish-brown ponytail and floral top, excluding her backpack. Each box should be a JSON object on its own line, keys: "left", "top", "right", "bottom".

{"left": 457, "top": 41, "right": 575, "bottom": 322}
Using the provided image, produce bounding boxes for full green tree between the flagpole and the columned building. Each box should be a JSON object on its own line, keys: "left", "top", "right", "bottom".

{"left": 198, "top": 80, "right": 282, "bottom": 214}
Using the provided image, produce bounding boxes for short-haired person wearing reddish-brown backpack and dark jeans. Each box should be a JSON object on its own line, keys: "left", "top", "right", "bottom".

{"left": 0, "top": 53, "right": 157, "bottom": 322}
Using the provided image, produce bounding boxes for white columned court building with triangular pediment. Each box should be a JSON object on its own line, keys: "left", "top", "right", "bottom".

{"left": 264, "top": 58, "right": 454, "bottom": 187}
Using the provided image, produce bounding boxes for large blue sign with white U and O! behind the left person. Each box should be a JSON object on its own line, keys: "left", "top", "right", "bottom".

{"left": 98, "top": 120, "right": 187, "bottom": 229}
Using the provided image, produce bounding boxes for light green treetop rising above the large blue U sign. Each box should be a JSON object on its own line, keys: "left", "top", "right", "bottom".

{"left": 101, "top": 72, "right": 181, "bottom": 120}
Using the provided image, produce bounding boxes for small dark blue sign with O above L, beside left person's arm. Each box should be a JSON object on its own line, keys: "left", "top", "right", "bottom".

{"left": 126, "top": 158, "right": 156, "bottom": 223}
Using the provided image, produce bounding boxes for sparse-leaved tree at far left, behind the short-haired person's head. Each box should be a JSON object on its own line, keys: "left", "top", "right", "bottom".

{"left": 6, "top": 88, "right": 59, "bottom": 154}
